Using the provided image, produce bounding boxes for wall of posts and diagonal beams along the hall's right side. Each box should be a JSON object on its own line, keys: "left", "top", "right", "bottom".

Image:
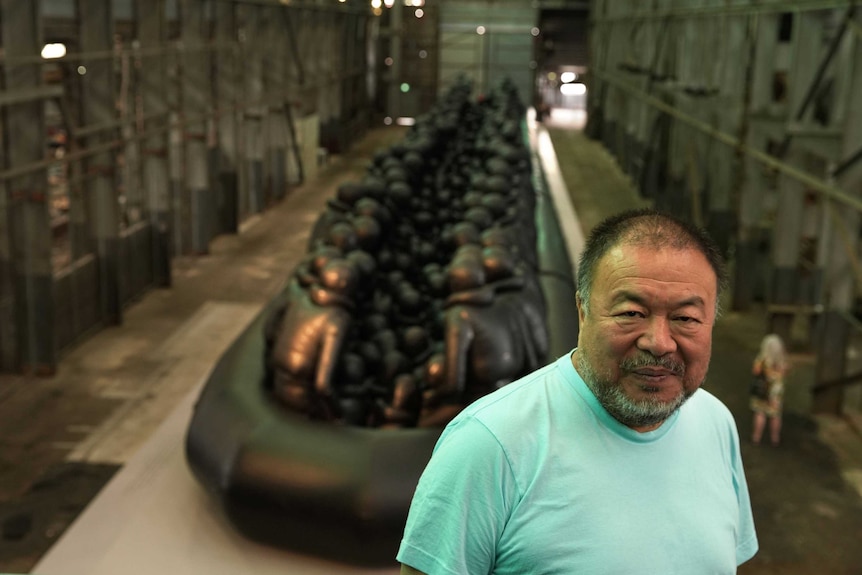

{"left": 587, "top": 0, "right": 862, "bottom": 413}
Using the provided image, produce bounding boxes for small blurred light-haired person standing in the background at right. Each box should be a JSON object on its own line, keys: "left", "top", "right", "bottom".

{"left": 751, "top": 333, "right": 788, "bottom": 445}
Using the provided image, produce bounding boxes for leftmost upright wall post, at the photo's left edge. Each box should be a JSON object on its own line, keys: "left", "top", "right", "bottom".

{"left": 0, "top": 0, "right": 57, "bottom": 375}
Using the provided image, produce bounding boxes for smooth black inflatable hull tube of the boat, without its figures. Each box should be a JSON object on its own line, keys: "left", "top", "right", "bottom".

{"left": 186, "top": 80, "right": 578, "bottom": 566}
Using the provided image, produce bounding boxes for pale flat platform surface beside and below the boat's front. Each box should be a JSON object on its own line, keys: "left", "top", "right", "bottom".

{"left": 32, "top": 364, "right": 399, "bottom": 575}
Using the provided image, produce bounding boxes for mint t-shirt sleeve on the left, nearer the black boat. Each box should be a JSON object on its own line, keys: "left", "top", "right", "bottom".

{"left": 397, "top": 416, "right": 518, "bottom": 575}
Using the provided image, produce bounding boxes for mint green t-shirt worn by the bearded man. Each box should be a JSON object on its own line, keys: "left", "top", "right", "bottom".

{"left": 397, "top": 355, "right": 758, "bottom": 575}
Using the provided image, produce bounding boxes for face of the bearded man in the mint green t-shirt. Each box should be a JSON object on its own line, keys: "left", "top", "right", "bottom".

{"left": 575, "top": 245, "right": 717, "bottom": 431}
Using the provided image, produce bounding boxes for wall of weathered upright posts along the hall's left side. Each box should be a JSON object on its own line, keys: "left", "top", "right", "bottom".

{"left": 0, "top": 0, "right": 377, "bottom": 374}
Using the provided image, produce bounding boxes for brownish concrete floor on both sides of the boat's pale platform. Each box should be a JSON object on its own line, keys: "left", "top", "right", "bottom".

{"left": 0, "top": 111, "right": 862, "bottom": 575}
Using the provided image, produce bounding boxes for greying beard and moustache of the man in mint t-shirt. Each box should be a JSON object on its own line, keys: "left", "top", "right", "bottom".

{"left": 577, "top": 350, "right": 694, "bottom": 428}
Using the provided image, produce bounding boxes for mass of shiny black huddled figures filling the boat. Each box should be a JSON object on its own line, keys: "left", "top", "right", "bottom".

{"left": 263, "top": 79, "right": 548, "bottom": 428}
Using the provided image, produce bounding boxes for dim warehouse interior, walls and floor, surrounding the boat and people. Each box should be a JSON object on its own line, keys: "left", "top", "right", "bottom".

{"left": 0, "top": 0, "right": 862, "bottom": 575}
